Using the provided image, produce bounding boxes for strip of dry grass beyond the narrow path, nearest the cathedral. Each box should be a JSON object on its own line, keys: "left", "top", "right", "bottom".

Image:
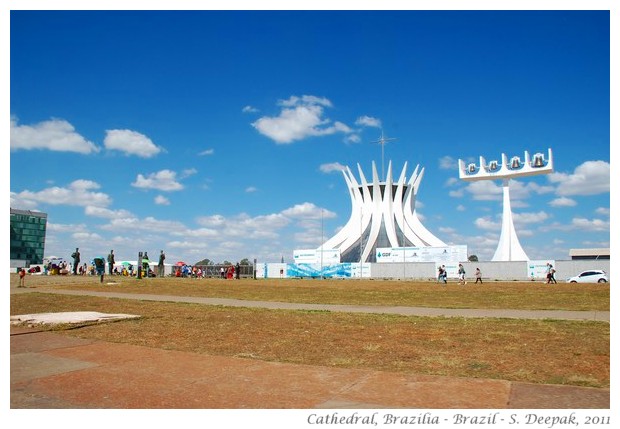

{"left": 11, "top": 274, "right": 610, "bottom": 311}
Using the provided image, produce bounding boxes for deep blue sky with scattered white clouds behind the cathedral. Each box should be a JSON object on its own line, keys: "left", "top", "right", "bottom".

{"left": 10, "top": 10, "right": 610, "bottom": 263}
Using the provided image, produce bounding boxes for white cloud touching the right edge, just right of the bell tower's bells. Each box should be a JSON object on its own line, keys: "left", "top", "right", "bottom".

{"left": 549, "top": 161, "right": 610, "bottom": 196}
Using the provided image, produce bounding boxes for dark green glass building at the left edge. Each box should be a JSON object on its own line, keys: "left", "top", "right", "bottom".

{"left": 11, "top": 209, "right": 47, "bottom": 266}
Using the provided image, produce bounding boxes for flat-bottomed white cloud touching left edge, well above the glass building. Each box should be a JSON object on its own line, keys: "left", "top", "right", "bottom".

{"left": 10, "top": 118, "right": 100, "bottom": 154}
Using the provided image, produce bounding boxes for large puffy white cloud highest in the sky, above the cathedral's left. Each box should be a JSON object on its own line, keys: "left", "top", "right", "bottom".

{"left": 252, "top": 95, "right": 352, "bottom": 144}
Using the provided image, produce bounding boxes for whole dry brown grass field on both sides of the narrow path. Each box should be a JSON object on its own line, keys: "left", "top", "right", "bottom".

{"left": 11, "top": 274, "right": 610, "bottom": 387}
